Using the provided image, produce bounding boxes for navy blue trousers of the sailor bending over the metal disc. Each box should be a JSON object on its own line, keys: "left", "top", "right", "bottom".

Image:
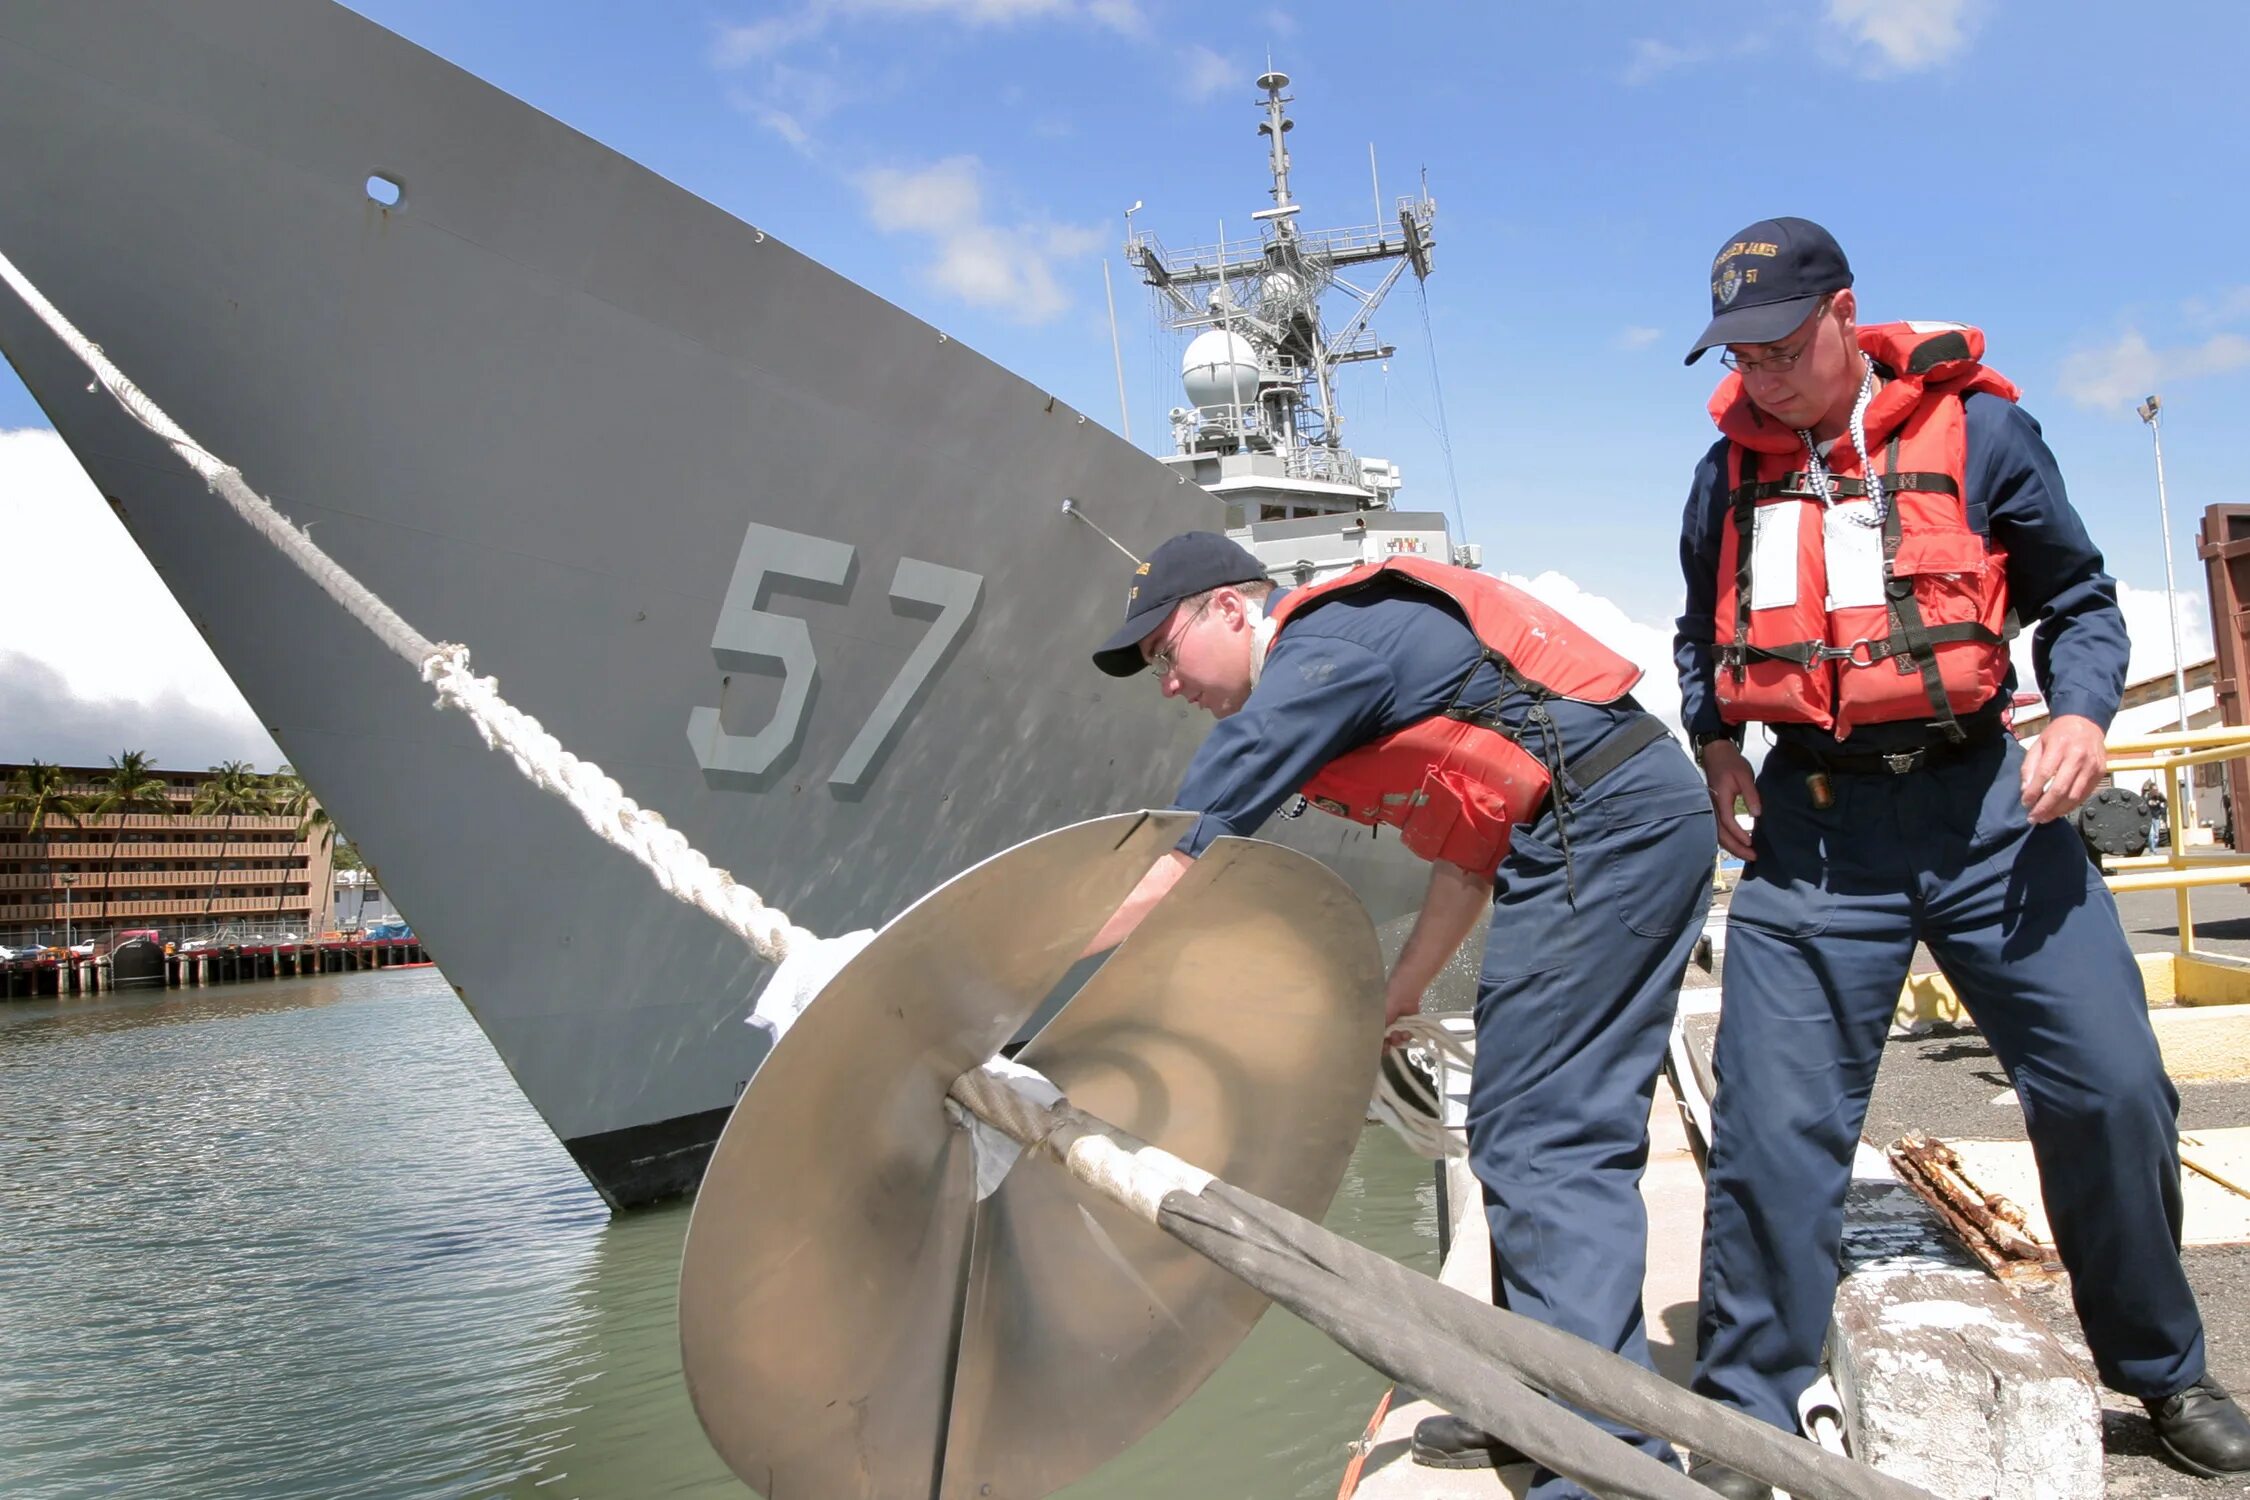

{"left": 1469, "top": 740, "right": 1717, "bottom": 1500}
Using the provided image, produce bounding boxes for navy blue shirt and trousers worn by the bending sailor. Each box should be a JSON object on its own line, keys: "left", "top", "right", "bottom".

{"left": 1177, "top": 589, "right": 1717, "bottom": 1500}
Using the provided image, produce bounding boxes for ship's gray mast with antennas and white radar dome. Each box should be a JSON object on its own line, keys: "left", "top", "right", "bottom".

{"left": 1125, "top": 72, "right": 1438, "bottom": 519}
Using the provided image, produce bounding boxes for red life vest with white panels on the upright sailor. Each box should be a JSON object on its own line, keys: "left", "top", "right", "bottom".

{"left": 1710, "top": 324, "right": 2016, "bottom": 740}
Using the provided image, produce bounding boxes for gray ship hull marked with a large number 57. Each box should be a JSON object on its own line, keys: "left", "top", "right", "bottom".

{"left": 0, "top": 0, "right": 1422, "bottom": 1205}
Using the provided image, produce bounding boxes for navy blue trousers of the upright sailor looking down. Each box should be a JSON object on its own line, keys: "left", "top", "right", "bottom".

{"left": 1694, "top": 735, "right": 2203, "bottom": 1430}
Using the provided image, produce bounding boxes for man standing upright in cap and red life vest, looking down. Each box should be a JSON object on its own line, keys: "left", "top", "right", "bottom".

{"left": 1676, "top": 218, "right": 2250, "bottom": 1498}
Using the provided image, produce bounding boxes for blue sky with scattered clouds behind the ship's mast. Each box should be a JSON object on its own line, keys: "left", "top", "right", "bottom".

{"left": 0, "top": 0, "right": 2250, "bottom": 755}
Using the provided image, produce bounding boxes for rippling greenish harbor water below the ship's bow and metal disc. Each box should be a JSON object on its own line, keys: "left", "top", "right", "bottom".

{"left": 0, "top": 969, "right": 1436, "bottom": 1500}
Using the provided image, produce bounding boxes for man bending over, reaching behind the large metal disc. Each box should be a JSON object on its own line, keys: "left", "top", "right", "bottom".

{"left": 1089, "top": 531, "right": 1712, "bottom": 1500}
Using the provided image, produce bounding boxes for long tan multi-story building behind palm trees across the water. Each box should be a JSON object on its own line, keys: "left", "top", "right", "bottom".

{"left": 0, "top": 765, "right": 331, "bottom": 947}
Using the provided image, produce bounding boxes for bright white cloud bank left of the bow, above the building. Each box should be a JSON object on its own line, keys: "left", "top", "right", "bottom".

{"left": 0, "top": 427, "right": 281, "bottom": 767}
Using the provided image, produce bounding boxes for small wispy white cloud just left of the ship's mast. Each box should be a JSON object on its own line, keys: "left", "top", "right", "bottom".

{"left": 860, "top": 155, "right": 1103, "bottom": 324}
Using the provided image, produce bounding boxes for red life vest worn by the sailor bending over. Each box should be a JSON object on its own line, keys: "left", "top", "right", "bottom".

{"left": 1269, "top": 558, "right": 1640, "bottom": 875}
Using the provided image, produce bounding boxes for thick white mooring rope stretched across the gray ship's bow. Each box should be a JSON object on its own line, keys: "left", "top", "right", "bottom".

{"left": 0, "top": 254, "right": 812, "bottom": 963}
